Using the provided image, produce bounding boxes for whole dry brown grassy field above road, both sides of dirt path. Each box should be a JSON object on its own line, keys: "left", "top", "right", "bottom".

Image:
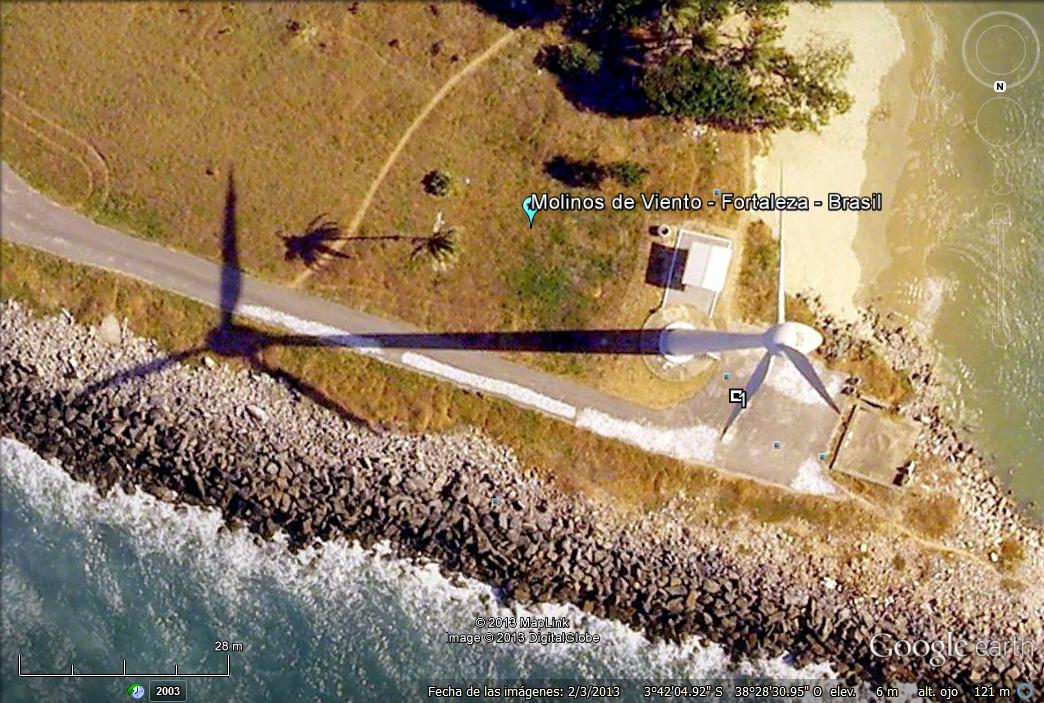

{"left": 2, "top": 3, "right": 746, "bottom": 402}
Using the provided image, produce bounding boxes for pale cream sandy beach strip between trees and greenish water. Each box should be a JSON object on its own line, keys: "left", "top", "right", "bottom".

{"left": 753, "top": 2, "right": 906, "bottom": 317}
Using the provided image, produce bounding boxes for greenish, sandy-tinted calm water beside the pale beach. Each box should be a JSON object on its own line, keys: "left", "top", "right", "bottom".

{"left": 860, "top": 2, "right": 1044, "bottom": 512}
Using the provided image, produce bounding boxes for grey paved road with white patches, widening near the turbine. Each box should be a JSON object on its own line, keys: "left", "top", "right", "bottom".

{"left": 0, "top": 163, "right": 838, "bottom": 490}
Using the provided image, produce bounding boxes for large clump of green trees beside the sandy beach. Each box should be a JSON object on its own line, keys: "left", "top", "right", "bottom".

{"left": 559, "top": 0, "right": 852, "bottom": 131}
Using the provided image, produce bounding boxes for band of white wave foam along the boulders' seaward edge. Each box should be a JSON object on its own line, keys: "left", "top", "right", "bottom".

{"left": 0, "top": 438, "right": 832, "bottom": 679}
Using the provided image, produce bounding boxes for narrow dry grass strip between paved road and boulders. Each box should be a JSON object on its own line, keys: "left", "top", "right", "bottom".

{"left": 6, "top": 241, "right": 875, "bottom": 532}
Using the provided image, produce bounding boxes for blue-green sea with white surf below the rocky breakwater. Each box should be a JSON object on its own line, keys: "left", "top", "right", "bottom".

{"left": 0, "top": 439, "right": 830, "bottom": 703}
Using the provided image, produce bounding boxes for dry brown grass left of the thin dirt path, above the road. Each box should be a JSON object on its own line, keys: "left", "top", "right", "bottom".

{"left": 3, "top": 3, "right": 501, "bottom": 269}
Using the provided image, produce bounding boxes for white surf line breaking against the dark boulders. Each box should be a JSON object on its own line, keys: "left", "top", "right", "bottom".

{"left": 0, "top": 437, "right": 836, "bottom": 685}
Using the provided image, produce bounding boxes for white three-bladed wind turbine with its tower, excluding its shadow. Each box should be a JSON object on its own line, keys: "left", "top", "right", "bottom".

{"left": 660, "top": 170, "right": 840, "bottom": 437}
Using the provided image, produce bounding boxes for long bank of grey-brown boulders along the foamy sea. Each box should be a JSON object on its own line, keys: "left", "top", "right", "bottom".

{"left": 0, "top": 303, "right": 1044, "bottom": 689}
